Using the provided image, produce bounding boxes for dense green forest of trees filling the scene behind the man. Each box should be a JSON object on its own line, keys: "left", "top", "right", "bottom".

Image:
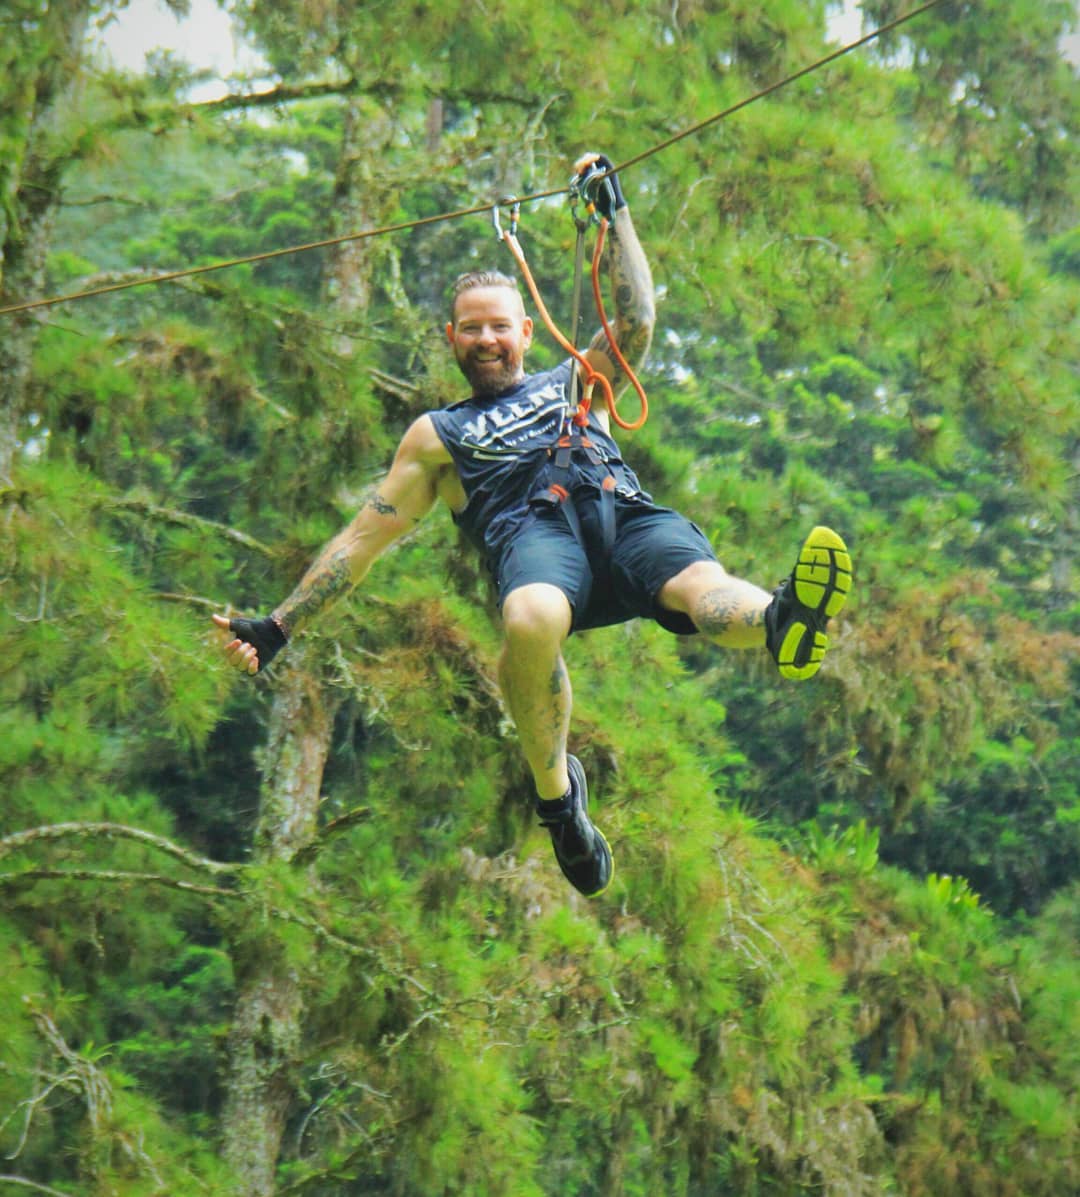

{"left": 0, "top": 0, "right": 1080, "bottom": 1197}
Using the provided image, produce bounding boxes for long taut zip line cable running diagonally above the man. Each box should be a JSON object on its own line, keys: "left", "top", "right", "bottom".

{"left": 0, "top": 0, "right": 946, "bottom": 316}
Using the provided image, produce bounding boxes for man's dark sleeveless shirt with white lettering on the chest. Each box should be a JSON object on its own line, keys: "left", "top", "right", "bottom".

{"left": 431, "top": 358, "right": 641, "bottom": 565}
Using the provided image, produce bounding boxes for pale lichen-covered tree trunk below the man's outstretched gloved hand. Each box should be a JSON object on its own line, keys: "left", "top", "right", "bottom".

{"left": 224, "top": 648, "right": 333, "bottom": 1197}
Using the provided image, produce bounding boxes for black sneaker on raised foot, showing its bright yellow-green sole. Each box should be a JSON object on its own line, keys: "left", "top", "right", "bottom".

{"left": 765, "top": 527, "right": 851, "bottom": 680}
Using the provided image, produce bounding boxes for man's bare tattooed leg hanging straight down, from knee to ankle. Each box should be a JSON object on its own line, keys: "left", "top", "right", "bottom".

{"left": 499, "top": 583, "right": 572, "bottom": 801}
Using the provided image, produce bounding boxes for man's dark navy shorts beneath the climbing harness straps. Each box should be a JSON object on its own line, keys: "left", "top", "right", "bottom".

{"left": 495, "top": 496, "right": 716, "bottom": 636}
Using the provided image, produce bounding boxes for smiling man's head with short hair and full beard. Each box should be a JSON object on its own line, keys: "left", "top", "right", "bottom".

{"left": 447, "top": 286, "right": 533, "bottom": 399}
